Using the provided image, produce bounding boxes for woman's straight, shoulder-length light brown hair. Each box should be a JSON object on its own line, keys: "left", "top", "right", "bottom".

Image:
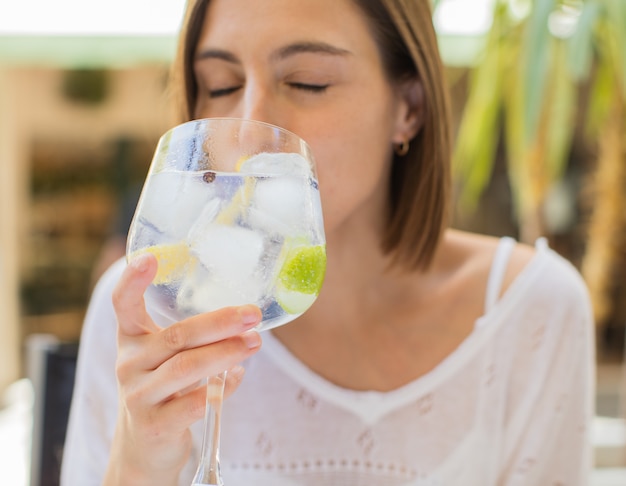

{"left": 167, "top": 0, "right": 451, "bottom": 269}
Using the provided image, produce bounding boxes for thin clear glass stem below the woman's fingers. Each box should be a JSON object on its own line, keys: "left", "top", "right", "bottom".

{"left": 192, "top": 371, "right": 226, "bottom": 486}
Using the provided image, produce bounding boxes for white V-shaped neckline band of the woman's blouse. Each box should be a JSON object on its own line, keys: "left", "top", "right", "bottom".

{"left": 263, "top": 248, "right": 547, "bottom": 425}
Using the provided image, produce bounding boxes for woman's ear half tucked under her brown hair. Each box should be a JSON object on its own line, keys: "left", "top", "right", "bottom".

{"left": 392, "top": 76, "right": 425, "bottom": 144}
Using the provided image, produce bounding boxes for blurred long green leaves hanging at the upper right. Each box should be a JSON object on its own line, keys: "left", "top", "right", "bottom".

{"left": 454, "top": 0, "right": 626, "bottom": 234}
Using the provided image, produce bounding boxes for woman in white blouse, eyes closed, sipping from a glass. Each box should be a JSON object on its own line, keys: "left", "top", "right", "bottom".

{"left": 63, "top": 0, "right": 593, "bottom": 486}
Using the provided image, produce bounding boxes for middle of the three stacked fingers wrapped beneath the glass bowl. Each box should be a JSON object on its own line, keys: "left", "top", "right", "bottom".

{"left": 136, "top": 330, "right": 261, "bottom": 405}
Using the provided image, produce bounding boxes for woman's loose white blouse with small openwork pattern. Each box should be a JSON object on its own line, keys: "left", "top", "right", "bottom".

{"left": 62, "top": 238, "right": 595, "bottom": 486}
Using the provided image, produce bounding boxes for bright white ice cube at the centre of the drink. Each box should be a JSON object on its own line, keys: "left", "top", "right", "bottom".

{"left": 189, "top": 220, "right": 263, "bottom": 283}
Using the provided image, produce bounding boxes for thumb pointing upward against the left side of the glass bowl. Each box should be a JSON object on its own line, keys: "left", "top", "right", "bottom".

{"left": 113, "top": 253, "right": 159, "bottom": 336}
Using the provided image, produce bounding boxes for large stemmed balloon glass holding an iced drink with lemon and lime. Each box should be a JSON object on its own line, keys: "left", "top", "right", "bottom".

{"left": 127, "top": 118, "right": 326, "bottom": 485}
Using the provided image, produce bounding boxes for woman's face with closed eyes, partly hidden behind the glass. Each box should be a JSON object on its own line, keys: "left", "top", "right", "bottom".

{"left": 194, "top": 0, "right": 414, "bottom": 236}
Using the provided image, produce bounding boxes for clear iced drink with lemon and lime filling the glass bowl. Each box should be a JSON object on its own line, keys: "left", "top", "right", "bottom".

{"left": 128, "top": 154, "right": 326, "bottom": 329}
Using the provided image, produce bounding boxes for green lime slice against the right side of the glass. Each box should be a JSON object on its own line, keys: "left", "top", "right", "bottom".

{"left": 276, "top": 245, "right": 326, "bottom": 314}
